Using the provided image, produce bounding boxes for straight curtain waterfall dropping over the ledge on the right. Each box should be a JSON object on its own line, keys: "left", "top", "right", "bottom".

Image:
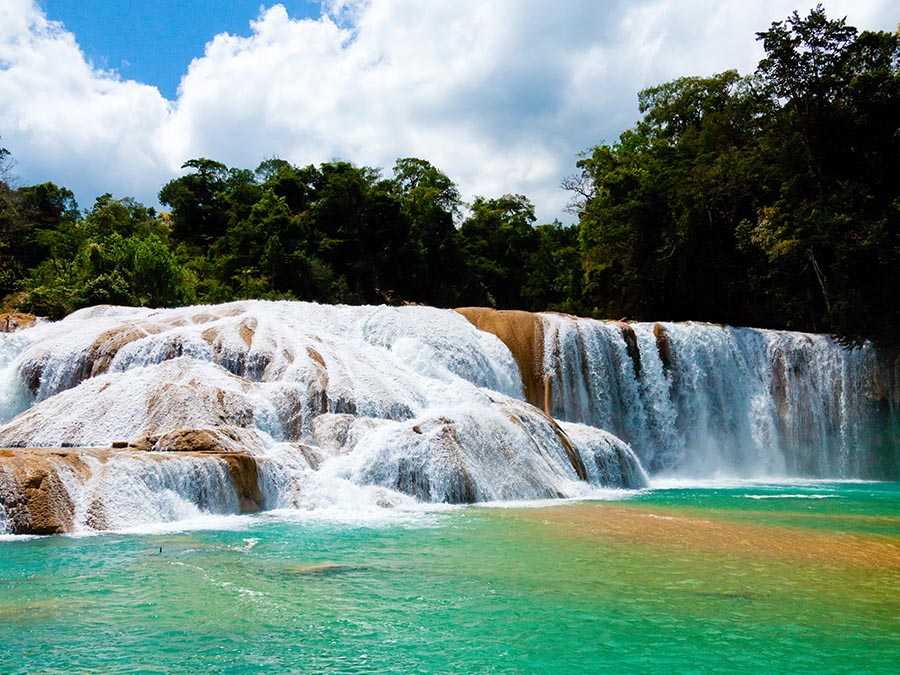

{"left": 542, "top": 314, "right": 900, "bottom": 479}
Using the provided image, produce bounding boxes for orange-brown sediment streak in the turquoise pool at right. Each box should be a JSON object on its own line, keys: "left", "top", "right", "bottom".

{"left": 516, "top": 503, "right": 900, "bottom": 572}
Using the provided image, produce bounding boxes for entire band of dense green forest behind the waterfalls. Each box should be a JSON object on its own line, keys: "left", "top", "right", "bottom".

{"left": 0, "top": 7, "right": 900, "bottom": 344}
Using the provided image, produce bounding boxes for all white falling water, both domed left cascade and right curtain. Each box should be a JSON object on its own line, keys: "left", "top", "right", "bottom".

{"left": 0, "top": 301, "right": 900, "bottom": 531}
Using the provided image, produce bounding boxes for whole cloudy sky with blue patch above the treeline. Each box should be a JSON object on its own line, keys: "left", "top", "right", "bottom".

{"left": 0, "top": 0, "right": 900, "bottom": 222}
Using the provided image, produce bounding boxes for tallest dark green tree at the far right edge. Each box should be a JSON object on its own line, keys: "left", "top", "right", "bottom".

{"left": 742, "top": 6, "right": 900, "bottom": 344}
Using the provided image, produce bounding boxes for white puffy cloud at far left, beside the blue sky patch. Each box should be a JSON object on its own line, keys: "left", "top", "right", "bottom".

{"left": 0, "top": 0, "right": 171, "bottom": 203}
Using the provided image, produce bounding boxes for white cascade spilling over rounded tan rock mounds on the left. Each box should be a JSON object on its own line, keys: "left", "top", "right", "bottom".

{"left": 0, "top": 302, "right": 646, "bottom": 529}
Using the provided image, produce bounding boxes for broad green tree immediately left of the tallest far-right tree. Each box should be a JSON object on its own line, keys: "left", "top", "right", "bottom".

{"left": 579, "top": 71, "right": 764, "bottom": 321}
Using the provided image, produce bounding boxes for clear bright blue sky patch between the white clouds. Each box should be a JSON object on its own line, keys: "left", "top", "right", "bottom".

{"left": 39, "top": 0, "right": 321, "bottom": 100}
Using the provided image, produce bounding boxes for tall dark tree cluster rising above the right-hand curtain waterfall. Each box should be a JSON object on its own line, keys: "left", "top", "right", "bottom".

{"left": 576, "top": 6, "right": 900, "bottom": 343}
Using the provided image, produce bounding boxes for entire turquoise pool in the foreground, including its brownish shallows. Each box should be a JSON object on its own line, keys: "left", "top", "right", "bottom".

{"left": 0, "top": 483, "right": 900, "bottom": 675}
